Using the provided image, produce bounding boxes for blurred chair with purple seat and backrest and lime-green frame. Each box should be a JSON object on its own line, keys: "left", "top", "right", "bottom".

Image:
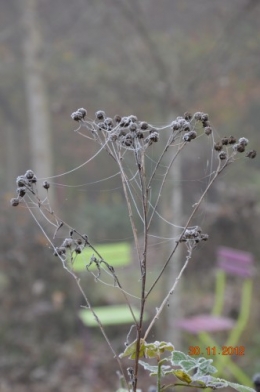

{"left": 177, "top": 247, "right": 254, "bottom": 385}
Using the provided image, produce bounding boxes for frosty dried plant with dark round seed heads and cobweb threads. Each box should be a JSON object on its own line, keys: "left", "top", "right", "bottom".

{"left": 11, "top": 108, "right": 256, "bottom": 392}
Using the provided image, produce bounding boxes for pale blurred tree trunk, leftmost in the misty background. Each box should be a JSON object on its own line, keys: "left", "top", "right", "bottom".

{"left": 19, "top": 0, "right": 52, "bottom": 202}
